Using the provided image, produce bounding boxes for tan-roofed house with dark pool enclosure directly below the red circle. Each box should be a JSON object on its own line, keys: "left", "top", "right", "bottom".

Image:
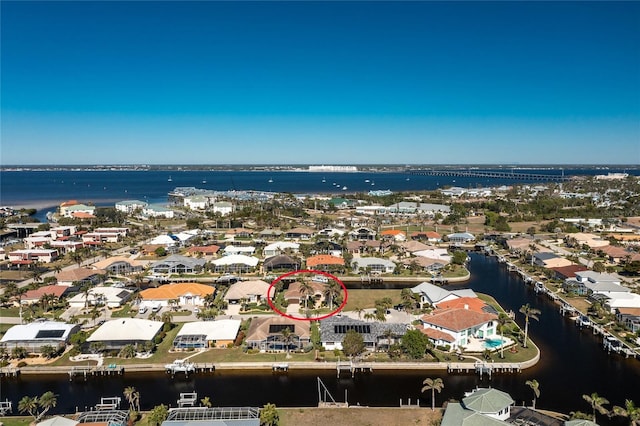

{"left": 245, "top": 316, "right": 311, "bottom": 352}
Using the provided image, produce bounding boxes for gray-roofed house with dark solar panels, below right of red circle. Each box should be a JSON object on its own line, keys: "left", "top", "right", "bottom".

{"left": 320, "top": 315, "right": 407, "bottom": 351}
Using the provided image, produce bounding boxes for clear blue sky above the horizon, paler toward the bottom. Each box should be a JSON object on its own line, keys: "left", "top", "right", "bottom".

{"left": 0, "top": 1, "right": 640, "bottom": 165}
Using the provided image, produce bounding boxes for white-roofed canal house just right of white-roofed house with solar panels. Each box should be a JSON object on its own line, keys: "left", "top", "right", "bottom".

{"left": 87, "top": 318, "right": 164, "bottom": 350}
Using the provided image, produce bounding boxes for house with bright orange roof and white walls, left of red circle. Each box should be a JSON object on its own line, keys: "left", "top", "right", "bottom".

{"left": 140, "top": 283, "right": 216, "bottom": 306}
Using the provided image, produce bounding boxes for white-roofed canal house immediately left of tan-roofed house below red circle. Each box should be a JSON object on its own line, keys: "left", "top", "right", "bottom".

{"left": 172, "top": 319, "right": 242, "bottom": 349}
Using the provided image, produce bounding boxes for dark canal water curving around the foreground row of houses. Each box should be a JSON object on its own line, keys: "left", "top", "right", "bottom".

{"left": 0, "top": 253, "right": 640, "bottom": 424}
